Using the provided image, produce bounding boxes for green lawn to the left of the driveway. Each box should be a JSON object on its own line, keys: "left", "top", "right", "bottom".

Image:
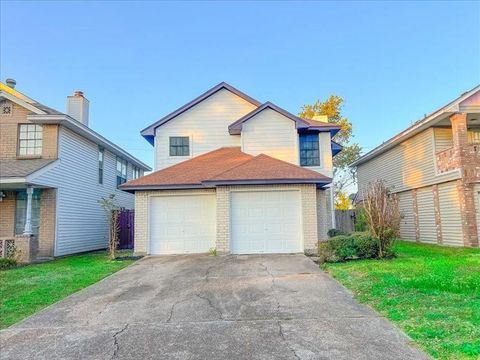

{"left": 0, "top": 251, "right": 133, "bottom": 329}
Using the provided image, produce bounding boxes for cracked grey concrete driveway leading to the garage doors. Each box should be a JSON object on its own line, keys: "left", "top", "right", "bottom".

{"left": 0, "top": 255, "right": 426, "bottom": 360}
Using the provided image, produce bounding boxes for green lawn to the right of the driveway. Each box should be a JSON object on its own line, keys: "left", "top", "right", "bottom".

{"left": 324, "top": 241, "right": 480, "bottom": 359}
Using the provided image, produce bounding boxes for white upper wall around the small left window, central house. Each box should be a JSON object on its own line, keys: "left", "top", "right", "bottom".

{"left": 154, "top": 89, "right": 256, "bottom": 170}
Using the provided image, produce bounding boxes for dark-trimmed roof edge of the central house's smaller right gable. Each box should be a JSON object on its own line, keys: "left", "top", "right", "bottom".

{"left": 228, "top": 101, "right": 340, "bottom": 136}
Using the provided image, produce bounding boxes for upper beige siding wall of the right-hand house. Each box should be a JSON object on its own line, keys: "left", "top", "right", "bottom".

{"left": 357, "top": 128, "right": 460, "bottom": 192}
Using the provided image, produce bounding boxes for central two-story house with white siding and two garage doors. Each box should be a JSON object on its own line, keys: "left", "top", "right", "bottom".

{"left": 121, "top": 83, "right": 341, "bottom": 254}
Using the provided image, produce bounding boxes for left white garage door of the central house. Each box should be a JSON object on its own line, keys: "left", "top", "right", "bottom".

{"left": 150, "top": 195, "right": 216, "bottom": 254}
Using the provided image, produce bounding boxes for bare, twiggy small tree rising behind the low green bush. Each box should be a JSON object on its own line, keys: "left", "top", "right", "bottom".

{"left": 362, "top": 180, "right": 401, "bottom": 258}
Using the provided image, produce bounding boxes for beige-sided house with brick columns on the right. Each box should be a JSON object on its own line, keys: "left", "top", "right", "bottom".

{"left": 353, "top": 86, "right": 480, "bottom": 247}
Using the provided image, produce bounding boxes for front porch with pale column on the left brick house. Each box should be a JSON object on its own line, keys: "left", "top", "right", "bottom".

{"left": 0, "top": 184, "right": 56, "bottom": 263}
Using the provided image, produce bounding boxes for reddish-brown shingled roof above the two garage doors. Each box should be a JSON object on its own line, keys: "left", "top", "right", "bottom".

{"left": 120, "top": 147, "right": 331, "bottom": 191}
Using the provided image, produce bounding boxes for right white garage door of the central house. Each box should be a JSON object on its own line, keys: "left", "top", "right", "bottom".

{"left": 230, "top": 191, "right": 303, "bottom": 254}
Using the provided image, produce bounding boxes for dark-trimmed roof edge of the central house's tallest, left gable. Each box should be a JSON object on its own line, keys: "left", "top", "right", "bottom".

{"left": 140, "top": 82, "right": 260, "bottom": 145}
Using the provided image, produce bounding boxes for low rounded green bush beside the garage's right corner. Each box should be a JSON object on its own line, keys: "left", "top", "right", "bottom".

{"left": 319, "top": 233, "right": 394, "bottom": 263}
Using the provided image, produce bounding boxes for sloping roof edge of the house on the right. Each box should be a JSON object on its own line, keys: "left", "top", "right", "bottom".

{"left": 350, "top": 85, "right": 480, "bottom": 166}
